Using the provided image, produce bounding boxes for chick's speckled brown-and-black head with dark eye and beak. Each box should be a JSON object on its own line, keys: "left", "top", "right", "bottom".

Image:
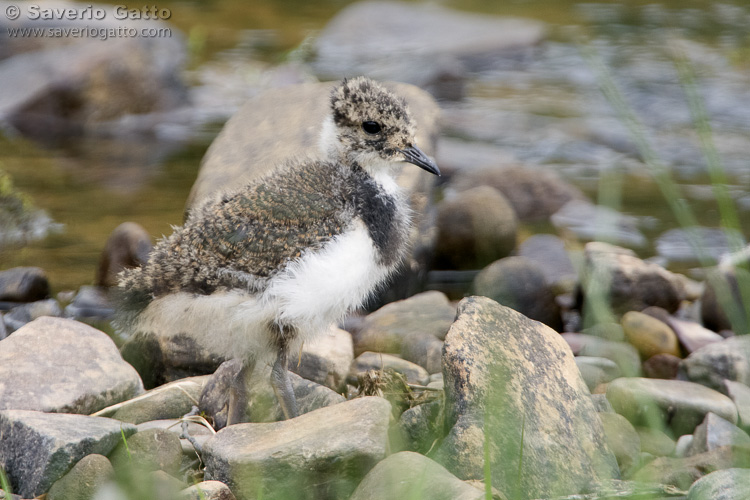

{"left": 326, "top": 77, "right": 440, "bottom": 175}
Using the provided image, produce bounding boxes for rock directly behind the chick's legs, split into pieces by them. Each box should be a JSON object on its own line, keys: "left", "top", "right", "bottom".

{"left": 198, "top": 359, "right": 345, "bottom": 429}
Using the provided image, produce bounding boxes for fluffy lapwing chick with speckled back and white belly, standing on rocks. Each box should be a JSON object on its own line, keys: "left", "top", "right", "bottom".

{"left": 119, "top": 77, "right": 440, "bottom": 424}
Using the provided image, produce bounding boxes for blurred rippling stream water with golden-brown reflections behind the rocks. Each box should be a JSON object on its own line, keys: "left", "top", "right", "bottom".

{"left": 0, "top": 0, "right": 750, "bottom": 291}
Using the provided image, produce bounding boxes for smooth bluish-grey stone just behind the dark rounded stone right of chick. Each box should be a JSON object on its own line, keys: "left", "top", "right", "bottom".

{"left": 518, "top": 234, "right": 580, "bottom": 292}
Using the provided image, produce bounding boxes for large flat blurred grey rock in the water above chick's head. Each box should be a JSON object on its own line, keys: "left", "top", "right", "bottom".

{"left": 313, "top": 1, "right": 545, "bottom": 98}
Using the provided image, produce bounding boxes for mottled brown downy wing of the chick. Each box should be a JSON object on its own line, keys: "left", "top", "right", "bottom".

{"left": 150, "top": 165, "right": 353, "bottom": 295}
